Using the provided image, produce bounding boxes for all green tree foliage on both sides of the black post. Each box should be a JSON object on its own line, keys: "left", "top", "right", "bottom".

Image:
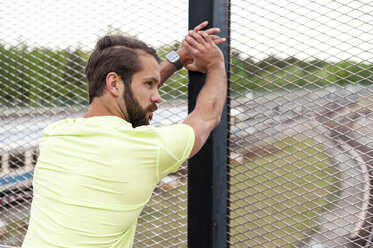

{"left": 0, "top": 43, "right": 373, "bottom": 107}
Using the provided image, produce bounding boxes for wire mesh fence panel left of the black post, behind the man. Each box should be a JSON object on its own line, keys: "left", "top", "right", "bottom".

{"left": 0, "top": 0, "right": 188, "bottom": 247}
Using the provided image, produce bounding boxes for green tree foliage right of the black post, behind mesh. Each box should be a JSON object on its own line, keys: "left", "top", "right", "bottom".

{"left": 231, "top": 51, "right": 373, "bottom": 92}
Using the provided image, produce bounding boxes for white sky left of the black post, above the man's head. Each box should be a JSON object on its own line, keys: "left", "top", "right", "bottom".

{"left": 0, "top": 0, "right": 188, "bottom": 49}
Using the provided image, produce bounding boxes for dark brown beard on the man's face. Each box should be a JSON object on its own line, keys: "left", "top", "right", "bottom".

{"left": 123, "top": 86, "right": 158, "bottom": 128}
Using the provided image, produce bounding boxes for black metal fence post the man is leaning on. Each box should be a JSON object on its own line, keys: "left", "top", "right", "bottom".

{"left": 188, "top": 0, "right": 229, "bottom": 248}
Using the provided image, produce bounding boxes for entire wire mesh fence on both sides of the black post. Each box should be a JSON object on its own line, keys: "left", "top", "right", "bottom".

{"left": 0, "top": 0, "right": 373, "bottom": 248}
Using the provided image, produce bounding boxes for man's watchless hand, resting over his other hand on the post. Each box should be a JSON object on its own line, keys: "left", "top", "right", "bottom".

{"left": 183, "top": 31, "right": 224, "bottom": 73}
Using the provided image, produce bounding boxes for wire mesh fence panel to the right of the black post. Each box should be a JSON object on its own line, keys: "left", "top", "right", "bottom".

{"left": 229, "top": 0, "right": 373, "bottom": 248}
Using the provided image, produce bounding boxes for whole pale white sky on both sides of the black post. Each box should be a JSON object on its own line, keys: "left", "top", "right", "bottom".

{"left": 0, "top": 0, "right": 373, "bottom": 62}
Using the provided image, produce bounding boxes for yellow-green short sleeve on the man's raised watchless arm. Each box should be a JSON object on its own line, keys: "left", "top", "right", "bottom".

{"left": 157, "top": 124, "right": 195, "bottom": 181}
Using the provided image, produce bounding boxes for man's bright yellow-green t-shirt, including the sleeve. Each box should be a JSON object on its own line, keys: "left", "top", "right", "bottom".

{"left": 22, "top": 116, "right": 194, "bottom": 248}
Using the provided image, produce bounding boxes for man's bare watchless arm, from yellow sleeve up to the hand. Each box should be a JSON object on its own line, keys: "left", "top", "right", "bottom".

{"left": 183, "top": 31, "right": 227, "bottom": 158}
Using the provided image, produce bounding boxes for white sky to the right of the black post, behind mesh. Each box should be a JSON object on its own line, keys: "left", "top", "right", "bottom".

{"left": 232, "top": 0, "right": 373, "bottom": 62}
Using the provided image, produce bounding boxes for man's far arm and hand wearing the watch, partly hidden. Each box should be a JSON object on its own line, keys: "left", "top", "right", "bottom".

{"left": 158, "top": 21, "right": 225, "bottom": 87}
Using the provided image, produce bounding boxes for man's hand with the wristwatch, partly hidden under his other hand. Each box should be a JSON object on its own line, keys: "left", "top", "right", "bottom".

{"left": 177, "top": 21, "right": 225, "bottom": 67}
